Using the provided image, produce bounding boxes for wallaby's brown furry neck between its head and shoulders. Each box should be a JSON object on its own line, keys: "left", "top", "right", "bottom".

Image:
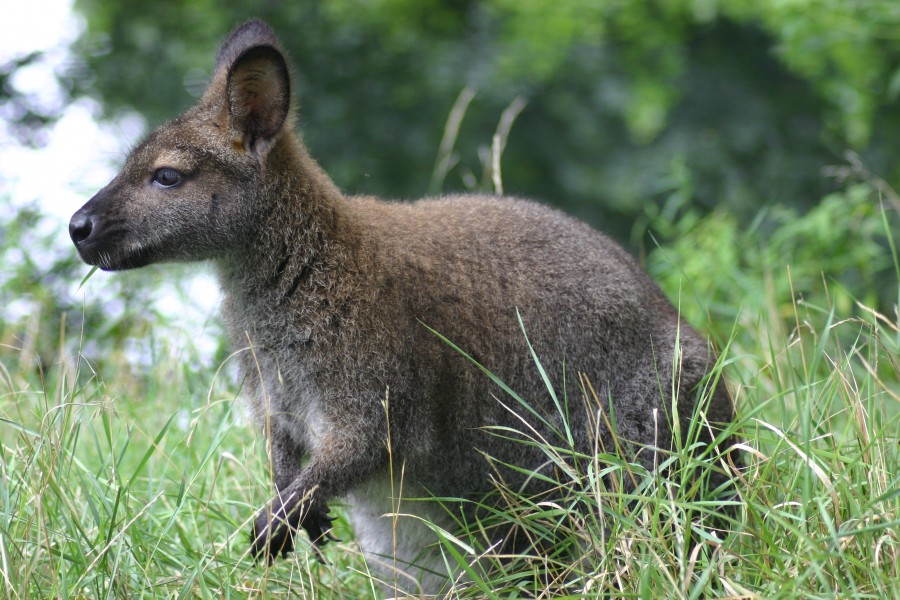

{"left": 219, "top": 132, "right": 346, "bottom": 304}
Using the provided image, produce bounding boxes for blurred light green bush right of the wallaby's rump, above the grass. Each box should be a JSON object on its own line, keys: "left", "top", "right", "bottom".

{"left": 647, "top": 164, "right": 900, "bottom": 341}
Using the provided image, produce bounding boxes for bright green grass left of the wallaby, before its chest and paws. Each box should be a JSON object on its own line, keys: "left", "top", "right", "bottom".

{"left": 0, "top": 332, "right": 367, "bottom": 598}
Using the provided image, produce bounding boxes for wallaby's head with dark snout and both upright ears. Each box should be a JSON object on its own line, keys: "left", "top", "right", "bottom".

{"left": 69, "top": 21, "right": 292, "bottom": 270}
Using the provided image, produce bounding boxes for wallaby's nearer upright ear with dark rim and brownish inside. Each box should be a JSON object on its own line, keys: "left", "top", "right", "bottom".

{"left": 227, "top": 46, "right": 291, "bottom": 158}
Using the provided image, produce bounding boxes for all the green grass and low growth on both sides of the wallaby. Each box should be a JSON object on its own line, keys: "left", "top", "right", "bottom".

{"left": 0, "top": 180, "right": 900, "bottom": 598}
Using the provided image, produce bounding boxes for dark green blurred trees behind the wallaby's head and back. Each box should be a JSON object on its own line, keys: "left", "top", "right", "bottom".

{"left": 71, "top": 0, "right": 900, "bottom": 241}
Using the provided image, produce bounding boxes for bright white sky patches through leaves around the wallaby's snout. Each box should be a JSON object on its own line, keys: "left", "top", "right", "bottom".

{"left": 0, "top": 0, "right": 219, "bottom": 364}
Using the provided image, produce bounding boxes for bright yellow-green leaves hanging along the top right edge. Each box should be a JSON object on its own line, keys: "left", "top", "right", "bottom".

{"left": 490, "top": 0, "right": 900, "bottom": 146}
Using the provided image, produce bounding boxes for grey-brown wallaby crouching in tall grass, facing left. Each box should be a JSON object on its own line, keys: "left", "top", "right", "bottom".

{"left": 69, "top": 20, "right": 733, "bottom": 593}
